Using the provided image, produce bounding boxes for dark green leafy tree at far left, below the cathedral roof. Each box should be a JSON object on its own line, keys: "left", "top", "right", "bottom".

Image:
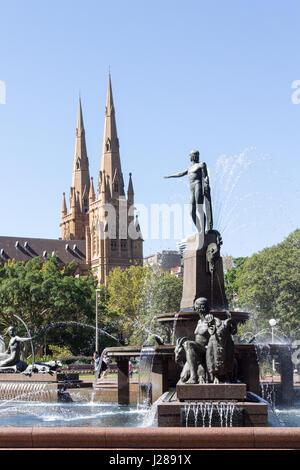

{"left": 0, "top": 256, "right": 115, "bottom": 354}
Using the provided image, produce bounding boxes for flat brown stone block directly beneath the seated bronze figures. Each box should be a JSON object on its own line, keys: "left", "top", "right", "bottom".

{"left": 176, "top": 381, "right": 247, "bottom": 401}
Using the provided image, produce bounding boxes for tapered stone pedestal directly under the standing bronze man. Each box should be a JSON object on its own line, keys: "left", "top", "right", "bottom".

{"left": 180, "top": 230, "right": 228, "bottom": 310}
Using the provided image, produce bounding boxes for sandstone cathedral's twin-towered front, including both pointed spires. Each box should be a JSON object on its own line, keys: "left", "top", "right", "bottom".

{"left": 60, "top": 75, "right": 143, "bottom": 284}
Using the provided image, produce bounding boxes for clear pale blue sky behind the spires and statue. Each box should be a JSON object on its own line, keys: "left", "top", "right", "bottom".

{"left": 0, "top": 0, "right": 300, "bottom": 256}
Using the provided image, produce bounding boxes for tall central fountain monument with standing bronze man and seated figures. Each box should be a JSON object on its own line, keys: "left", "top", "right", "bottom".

{"left": 107, "top": 150, "right": 293, "bottom": 426}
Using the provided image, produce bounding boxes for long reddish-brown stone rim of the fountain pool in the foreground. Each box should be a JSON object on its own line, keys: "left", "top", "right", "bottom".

{"left": 0, "top": 427, "right": 300, "bottom": 450}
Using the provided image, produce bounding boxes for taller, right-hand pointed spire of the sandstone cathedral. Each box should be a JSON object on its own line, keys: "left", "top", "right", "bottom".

{"left": 101, "top": 74, "right": 124, "bottom": 197}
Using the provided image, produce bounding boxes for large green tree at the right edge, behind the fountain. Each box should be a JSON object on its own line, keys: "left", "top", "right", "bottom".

{"left": 234, "top": 229, "right": 300, "bottom": 337}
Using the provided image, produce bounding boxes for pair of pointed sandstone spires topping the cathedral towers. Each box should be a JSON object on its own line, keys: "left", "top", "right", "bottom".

{"left": 62, "top": 74, "right": 134, "bottom": 226}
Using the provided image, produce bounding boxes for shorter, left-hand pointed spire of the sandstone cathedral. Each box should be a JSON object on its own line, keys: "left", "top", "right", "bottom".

{"left": 72, "top": 98, "right": 90, "bottom": 212}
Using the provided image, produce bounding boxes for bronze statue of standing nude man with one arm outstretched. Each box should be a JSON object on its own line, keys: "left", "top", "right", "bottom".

{"left": 165, "top": 150, "right": 213, "bottom": 233}
